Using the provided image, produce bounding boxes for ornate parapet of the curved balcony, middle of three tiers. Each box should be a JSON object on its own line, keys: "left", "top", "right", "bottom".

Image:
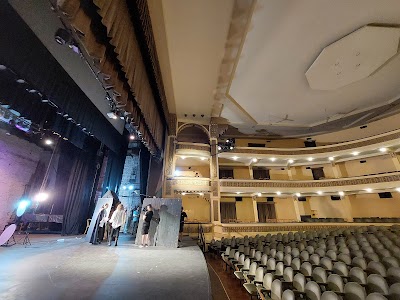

{"left": 220, "top": 172, "right": 400, "bottom": 188}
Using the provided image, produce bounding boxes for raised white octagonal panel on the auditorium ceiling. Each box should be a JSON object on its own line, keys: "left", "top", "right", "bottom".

{"left": 306, "top": 26, "right": 400, "bottom": 90}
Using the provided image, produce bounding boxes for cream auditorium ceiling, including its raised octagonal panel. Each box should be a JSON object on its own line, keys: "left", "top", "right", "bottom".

{"left": 148, "top": 0, "right": 400, "bottom": 138}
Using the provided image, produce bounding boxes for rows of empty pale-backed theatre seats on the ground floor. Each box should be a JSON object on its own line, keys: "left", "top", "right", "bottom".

{"left": 208, "top": 225, "right": 400, "bottom": 300}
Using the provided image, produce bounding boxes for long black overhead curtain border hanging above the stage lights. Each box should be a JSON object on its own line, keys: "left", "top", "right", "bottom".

{"left": 0, "top": 1, "right": 123, "bottom": 153}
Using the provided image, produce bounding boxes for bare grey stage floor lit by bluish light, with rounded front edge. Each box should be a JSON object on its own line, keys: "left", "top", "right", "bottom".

{"left": 0, "top": 235, "right": 211, "bottom": 300}
